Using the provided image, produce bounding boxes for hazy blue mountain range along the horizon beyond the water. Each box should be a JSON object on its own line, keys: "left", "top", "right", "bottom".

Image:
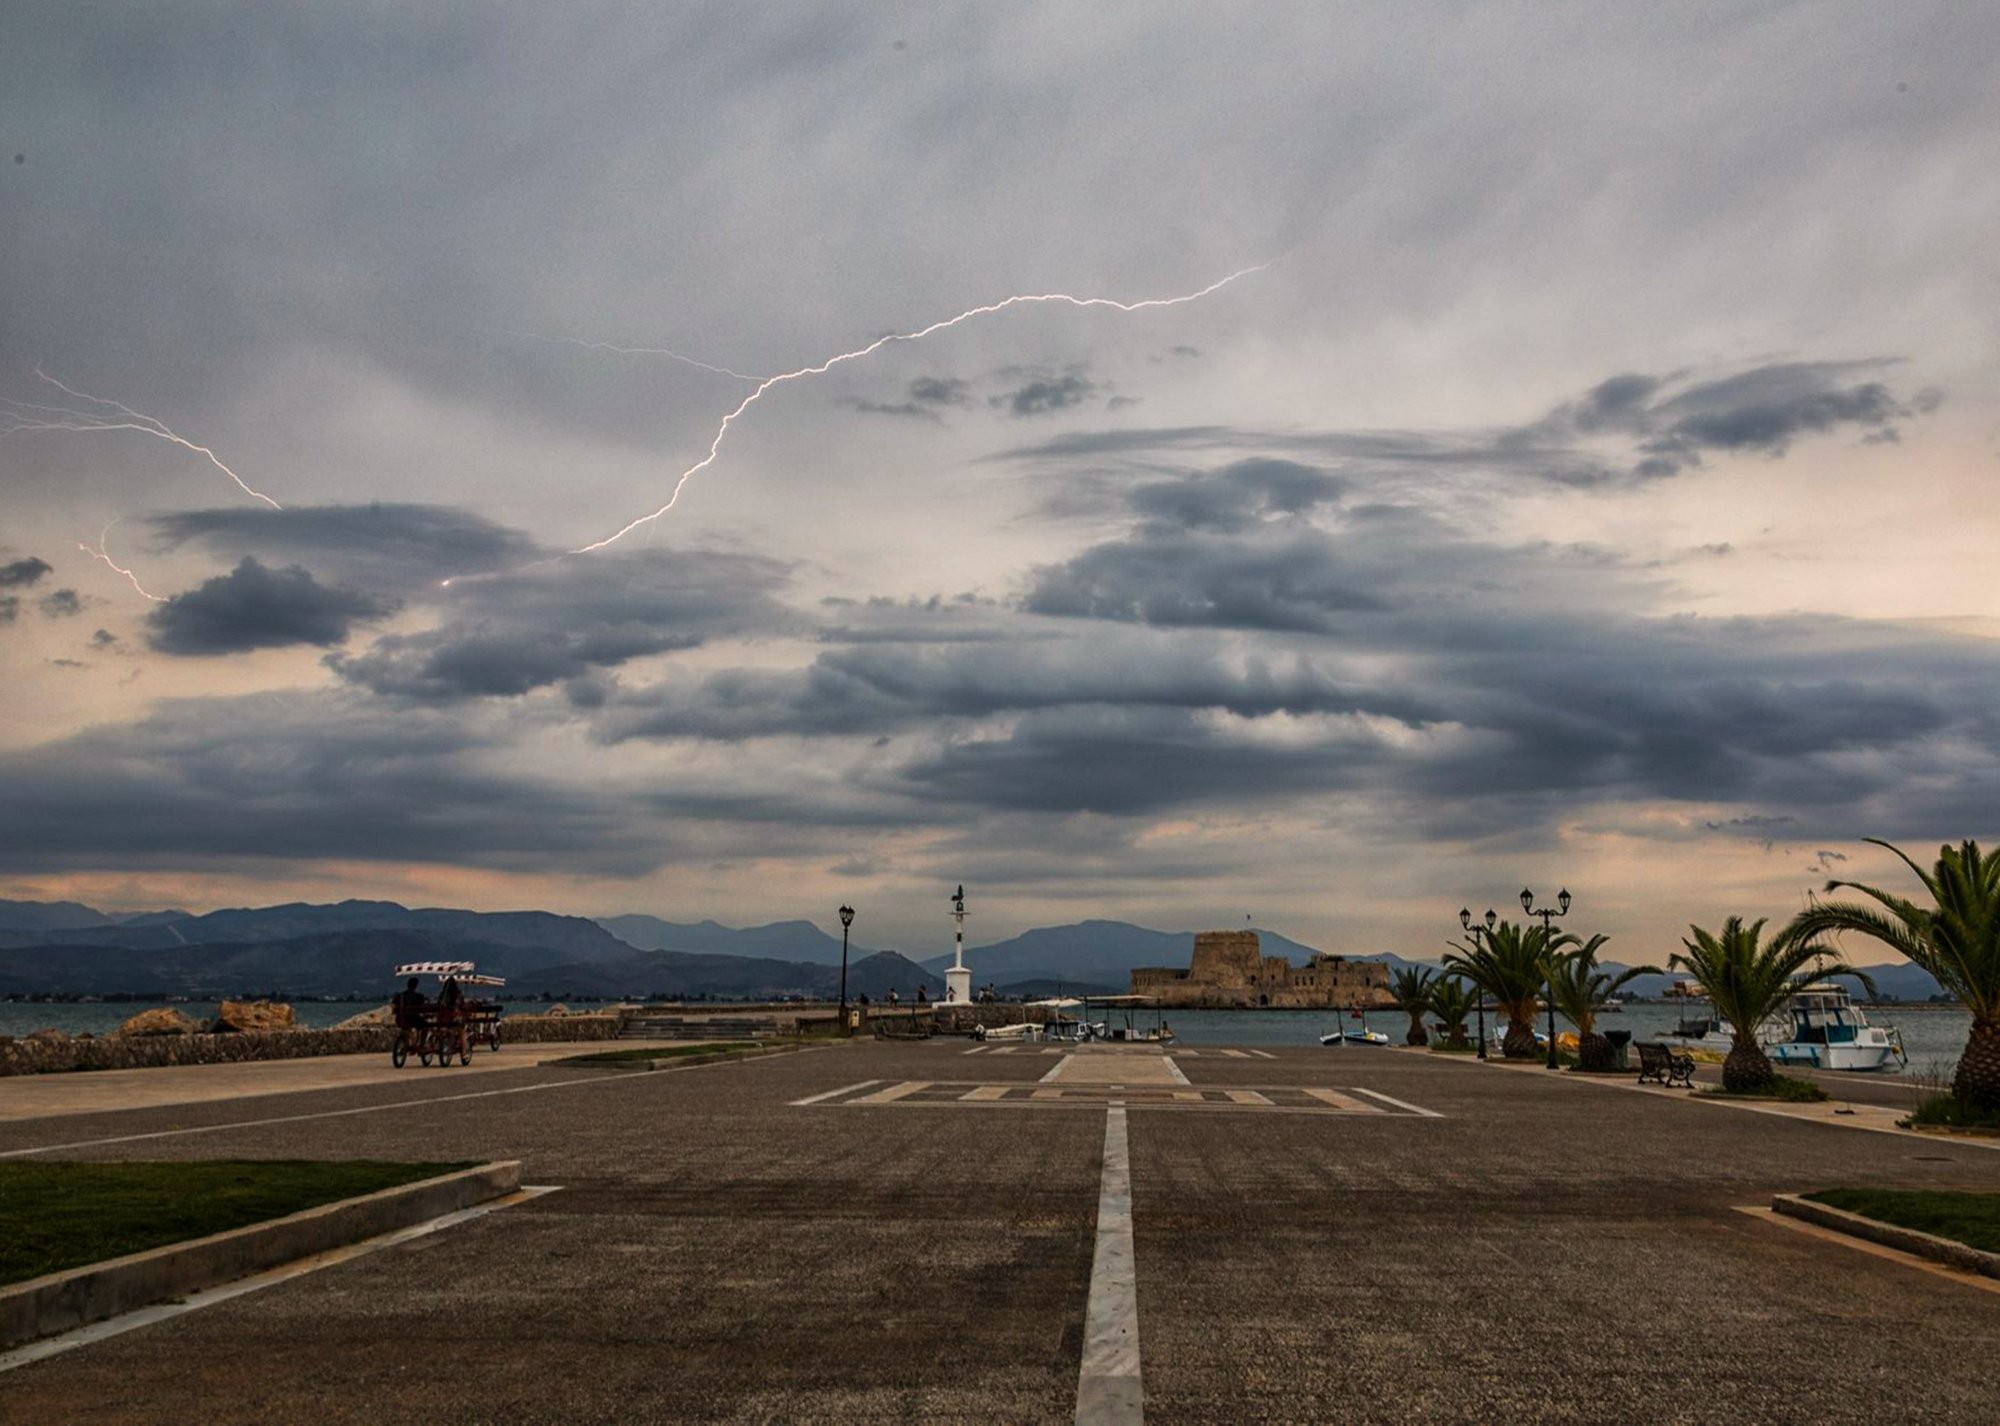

{"left": 0, "top": 900, "right": 1938, "bottom": 1000}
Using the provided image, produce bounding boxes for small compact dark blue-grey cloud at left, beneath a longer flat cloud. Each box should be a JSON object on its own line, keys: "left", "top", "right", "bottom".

{"left": 146, "top": 556, "right": 392, "bottom": 658}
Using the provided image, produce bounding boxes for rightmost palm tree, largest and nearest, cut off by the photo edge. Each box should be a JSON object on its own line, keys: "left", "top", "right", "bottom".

{"left": 1792, "top": 838, "right": 2000, "bottom": 1110}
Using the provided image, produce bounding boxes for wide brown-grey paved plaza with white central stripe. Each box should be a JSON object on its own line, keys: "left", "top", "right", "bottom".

{"left": 0, "top": 1040, "right": 2000, "bottom": 1424}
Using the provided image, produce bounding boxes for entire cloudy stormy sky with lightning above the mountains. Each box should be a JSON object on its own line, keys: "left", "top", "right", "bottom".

{"left": 0, "top": 0, "right": 2000, "bottom": 958}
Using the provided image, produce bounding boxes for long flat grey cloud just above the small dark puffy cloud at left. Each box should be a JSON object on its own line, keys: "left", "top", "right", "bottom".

{"left": 150, "top": 504, "right": 546, "bottom": 590}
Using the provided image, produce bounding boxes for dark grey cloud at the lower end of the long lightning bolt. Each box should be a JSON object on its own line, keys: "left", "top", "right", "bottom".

{"left": 326, "top": 552, "right": 788, "bottom": 702}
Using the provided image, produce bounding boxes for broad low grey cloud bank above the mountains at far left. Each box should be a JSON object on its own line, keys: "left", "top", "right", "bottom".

{"left": 0, "top": 694, "right": 662, "bottom": 874}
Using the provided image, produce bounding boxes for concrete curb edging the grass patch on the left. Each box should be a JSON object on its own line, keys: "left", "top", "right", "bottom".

{"left": 0, "top": 1160, "right": 520, "bottom": 1346}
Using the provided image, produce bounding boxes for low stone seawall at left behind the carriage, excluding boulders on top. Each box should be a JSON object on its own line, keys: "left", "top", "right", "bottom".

{"left": 0, "top": 1014, "right": 624, "bottom": 1076}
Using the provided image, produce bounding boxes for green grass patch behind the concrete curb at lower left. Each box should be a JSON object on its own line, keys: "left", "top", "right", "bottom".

{"left": 0, "top": 1158, "right": 472, "bottom": 1284}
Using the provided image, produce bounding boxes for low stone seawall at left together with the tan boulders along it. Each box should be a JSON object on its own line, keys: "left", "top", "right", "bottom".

{"left": 0, "top": 1000, "right": 624, "bottom": 1076}
